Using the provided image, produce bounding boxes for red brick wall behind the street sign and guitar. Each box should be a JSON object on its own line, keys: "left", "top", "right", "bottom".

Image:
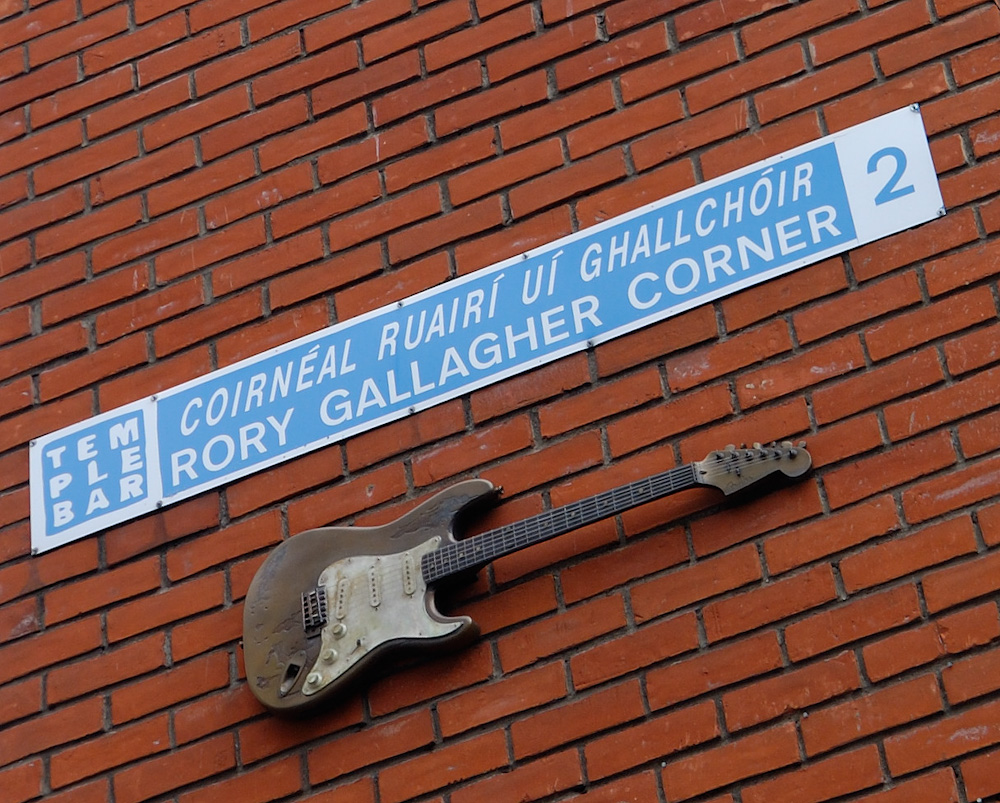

{"left": 0, "top": 0, "right": 1000, "bottom": 803}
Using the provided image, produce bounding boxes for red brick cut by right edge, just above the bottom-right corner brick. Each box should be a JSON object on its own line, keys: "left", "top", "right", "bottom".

{"left": 884, "top": 701, "right": 1000, "bottom": 776}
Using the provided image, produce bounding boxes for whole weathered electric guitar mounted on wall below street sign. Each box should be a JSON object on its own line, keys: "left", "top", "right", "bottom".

{"left": 243, "top": 442, "right": 812, "bottom": 713}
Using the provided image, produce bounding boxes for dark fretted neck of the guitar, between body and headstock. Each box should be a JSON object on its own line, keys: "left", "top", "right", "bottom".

{"left": 421, "top": 463, "right": 700, "bottom": 583}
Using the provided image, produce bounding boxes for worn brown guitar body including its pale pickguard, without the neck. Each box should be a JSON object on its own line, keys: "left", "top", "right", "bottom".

{"left": 243, "top": 479, "right": 497, "bottom": 713}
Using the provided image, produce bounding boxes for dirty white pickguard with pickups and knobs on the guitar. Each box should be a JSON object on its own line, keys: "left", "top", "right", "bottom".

{"left": 302, "top": 536, "right": 464, "bottom": 696}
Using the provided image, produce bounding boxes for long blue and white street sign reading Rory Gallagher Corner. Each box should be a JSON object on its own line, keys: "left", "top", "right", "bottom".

{"left": 30, "top": 107, "right": 944, "bottom": 552}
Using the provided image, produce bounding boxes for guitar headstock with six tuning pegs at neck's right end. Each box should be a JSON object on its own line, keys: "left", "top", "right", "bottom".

{"left": 694, "top": 441, "right": 812, "bottom": 495}
